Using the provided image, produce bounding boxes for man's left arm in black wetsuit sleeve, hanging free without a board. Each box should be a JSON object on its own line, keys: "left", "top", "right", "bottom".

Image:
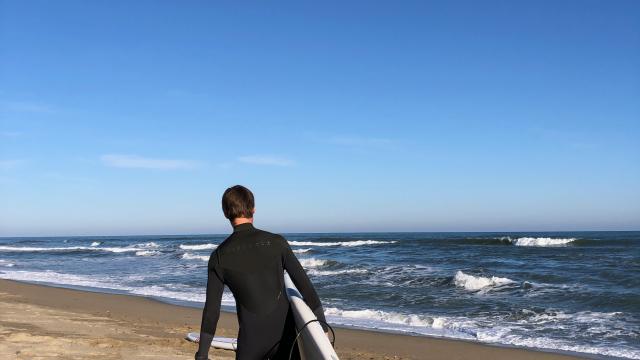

{"left": 195, "top": 251, "right": 224, "bottom": 360}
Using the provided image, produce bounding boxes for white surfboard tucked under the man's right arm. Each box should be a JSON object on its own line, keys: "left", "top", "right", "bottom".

{"left": 284, "top": 274, "right": 338, "bottom": 360}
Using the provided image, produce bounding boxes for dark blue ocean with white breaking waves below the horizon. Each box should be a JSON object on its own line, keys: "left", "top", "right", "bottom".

{"left": 0, "top": 232, "right": 640, "bottom": 359}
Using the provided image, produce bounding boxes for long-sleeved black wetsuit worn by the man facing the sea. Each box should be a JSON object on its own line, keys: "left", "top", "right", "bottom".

{"left": 196, "top": 223, "right": 325, "bottom": 360}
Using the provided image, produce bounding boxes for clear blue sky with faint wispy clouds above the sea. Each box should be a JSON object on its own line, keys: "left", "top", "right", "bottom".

{"left": 0, "top": 0, "right": 640, "bottom": 236}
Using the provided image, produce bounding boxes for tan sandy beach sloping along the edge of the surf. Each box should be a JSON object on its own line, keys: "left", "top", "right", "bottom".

{"left": 0, "top": 279, "right": 592, "bottom": 360}
